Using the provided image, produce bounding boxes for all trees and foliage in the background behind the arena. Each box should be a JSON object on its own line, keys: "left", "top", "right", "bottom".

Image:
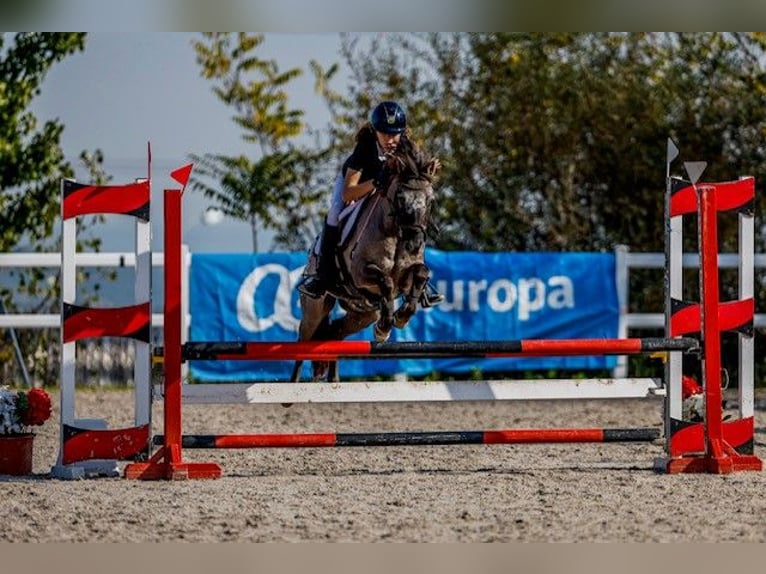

{"left": 0, "top": 32, "right": 766, "bottom": 390}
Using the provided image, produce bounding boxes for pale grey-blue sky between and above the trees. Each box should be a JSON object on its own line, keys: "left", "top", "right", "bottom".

{"left": 32, "top": 32, "right": 342, "bottom": 253}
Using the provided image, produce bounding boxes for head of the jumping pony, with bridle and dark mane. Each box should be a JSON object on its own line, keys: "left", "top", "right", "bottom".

{"left": 382, "top": 153, "right": 441, "bottom": 236}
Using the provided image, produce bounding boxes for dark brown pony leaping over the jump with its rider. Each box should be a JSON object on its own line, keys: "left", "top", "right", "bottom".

{"left": 291, "top": 148, "right": 440, "bottom": 381}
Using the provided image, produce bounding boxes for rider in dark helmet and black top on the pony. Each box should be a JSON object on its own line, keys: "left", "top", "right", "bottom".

{"left": 298, "top": 101, "right": 444, "bottom": 307}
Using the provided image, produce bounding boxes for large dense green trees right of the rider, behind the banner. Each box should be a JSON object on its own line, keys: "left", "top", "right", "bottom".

{"left": 328, "top": 32, "right": 766, "bottom": 382}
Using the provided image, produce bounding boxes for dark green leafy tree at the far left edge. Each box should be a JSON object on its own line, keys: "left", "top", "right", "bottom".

{"left": 0, "top": 33, "right": 117, "bottom": 390}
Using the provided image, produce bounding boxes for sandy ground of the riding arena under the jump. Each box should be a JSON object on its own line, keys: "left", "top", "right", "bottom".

{"left": 0, "top": 391, "right": 766, "bottom": 542}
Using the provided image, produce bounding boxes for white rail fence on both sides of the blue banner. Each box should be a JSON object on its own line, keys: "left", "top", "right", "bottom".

{"left": 0, "top": 247, "right": 766, "bottom": 377}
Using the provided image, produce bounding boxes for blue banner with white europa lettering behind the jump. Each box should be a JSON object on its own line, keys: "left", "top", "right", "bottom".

{"left": 190, "top": 249, "right": 619, "bottom": 381}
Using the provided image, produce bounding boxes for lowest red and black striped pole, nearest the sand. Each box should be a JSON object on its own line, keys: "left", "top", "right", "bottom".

{"left": 154, "top": 428, "right": 661, "bottom": 449}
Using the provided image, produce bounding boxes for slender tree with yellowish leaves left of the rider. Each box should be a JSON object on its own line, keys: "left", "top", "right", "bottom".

{"left": 190, "top": 33, "right": 327, "bottom": 251}
